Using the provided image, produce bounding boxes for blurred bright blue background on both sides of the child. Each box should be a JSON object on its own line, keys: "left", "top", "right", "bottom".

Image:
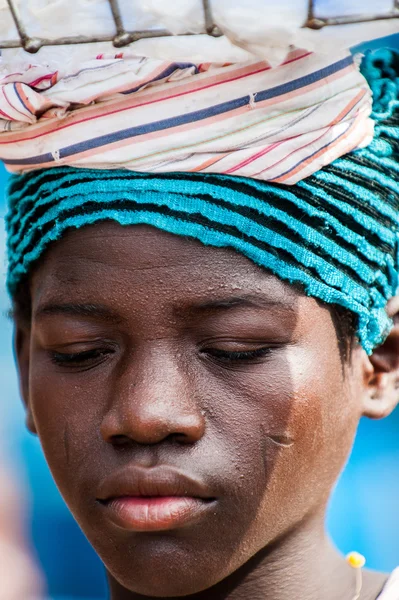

{"left": 0, "top": 36, "right": 399, "bottom": 600}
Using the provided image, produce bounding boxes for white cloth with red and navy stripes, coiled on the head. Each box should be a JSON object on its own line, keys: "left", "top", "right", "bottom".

{"left": 0, "top": 49, "right": 373, "bottom": 185}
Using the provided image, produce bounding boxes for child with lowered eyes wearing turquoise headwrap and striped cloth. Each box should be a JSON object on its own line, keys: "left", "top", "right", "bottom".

{"left": 0, "top": 1, "right": 399, "bottom": 600}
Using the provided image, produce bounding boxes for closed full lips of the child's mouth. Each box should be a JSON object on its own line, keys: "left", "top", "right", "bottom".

{"left": 97, "top": 467, "right": 215, "bottom": 532}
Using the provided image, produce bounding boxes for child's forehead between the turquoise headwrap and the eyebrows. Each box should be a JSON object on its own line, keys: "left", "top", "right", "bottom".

{"left": 32, "top": 222, "right": 304, "bottom": 308}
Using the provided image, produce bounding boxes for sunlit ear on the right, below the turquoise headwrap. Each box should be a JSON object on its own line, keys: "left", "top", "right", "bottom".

{"left": 363, "top": 296, "right": 399, "bottom": 419}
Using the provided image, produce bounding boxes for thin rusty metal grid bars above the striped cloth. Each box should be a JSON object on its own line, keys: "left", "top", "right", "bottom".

{"left": 0, "top": 0, "right": 399, "bottom": 54}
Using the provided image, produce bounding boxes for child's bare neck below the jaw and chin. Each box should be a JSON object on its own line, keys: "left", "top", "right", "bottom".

{"left": 109, "top": 510, "right": 355, "bottom": 600}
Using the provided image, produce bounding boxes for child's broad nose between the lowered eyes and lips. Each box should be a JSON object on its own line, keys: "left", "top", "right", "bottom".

{"left": 101, "top": 352, "right": 205, "bottom": 445}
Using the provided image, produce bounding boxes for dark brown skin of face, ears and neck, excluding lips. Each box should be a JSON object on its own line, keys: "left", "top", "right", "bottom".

{"left": 16, "top": 223, "right": 399, "bottom": 600}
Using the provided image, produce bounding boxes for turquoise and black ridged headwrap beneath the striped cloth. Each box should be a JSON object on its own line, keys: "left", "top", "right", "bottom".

{"left": 7, "top": 53, "right": 399, "bottom": 353}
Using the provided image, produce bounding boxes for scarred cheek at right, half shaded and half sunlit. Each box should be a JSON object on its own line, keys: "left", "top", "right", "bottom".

{"left": 214, "top": 345, "right": 358, "bottom": 548}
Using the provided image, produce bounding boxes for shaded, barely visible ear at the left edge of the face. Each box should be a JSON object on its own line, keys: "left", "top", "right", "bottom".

{"left": 14, "top": 321, "right": 37, "bottom": 433}
